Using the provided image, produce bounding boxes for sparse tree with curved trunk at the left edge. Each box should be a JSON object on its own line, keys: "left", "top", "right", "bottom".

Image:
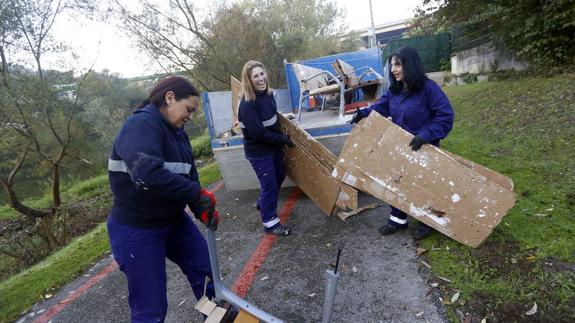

{"left": 0, "top": 0, "right": 98, "bottom": 254}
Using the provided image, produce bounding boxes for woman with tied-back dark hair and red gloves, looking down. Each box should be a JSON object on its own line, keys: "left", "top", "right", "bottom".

{"left": 107, "top": 77, "right": 219, "bottom": 322}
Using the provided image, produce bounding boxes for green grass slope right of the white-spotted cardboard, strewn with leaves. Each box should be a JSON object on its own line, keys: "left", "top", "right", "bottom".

{"left": 422, "top": 74, "right": 575, "bottom": 322}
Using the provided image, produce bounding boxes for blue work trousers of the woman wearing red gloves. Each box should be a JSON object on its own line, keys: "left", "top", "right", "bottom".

{"left": 108, "top": 216, "right": 215, "bottom": 322}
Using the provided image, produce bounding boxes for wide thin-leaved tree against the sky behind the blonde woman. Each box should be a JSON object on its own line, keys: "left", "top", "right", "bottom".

{"left": 112, "top": 0, "right": 343, "bottom": 91}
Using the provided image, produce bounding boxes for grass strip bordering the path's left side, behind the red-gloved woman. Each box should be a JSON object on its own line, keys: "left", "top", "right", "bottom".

{"left": 0, "top": 163, "right": 220, "bottom": 322}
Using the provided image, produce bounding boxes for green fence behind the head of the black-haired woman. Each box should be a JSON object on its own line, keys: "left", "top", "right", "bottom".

{"left": 383, "top": 32, "right": 451, "bottom": 73}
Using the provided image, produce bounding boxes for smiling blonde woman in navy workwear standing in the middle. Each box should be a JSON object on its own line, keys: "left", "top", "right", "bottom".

{"left": 238, "top": 61, "right": 295, "bottom": 236}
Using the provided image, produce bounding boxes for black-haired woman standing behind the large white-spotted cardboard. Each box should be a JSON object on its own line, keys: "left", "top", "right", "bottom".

{"left": 351, "top": 47, "right": 454, "bottom": 239}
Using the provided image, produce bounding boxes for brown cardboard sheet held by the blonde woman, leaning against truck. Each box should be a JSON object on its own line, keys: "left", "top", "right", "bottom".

{"left": 278, "top": 114, "right": 358, "bottom": 215}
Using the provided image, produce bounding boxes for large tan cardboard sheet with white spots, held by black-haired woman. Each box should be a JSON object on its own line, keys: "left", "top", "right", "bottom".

{"left": 332, "top": 113, "right": 515, "bottom": 247}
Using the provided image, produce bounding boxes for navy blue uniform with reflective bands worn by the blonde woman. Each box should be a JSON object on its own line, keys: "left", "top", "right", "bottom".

{"left": 238, "top": 92, "right": 285, "bottom": 230}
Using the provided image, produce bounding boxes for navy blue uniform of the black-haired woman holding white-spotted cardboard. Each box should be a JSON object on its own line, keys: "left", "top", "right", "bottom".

{"left": 358, "top": 80, "right": 454, "bottom": 226}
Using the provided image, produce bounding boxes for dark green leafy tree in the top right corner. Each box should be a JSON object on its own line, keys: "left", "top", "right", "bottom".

{"left": 418, "top": 0, "right": 575, "bottom": 67}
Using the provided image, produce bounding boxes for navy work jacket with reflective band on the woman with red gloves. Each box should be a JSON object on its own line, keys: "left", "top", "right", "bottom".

{"left": 108, "top": 104, "right": 201, "bottom": 227}
